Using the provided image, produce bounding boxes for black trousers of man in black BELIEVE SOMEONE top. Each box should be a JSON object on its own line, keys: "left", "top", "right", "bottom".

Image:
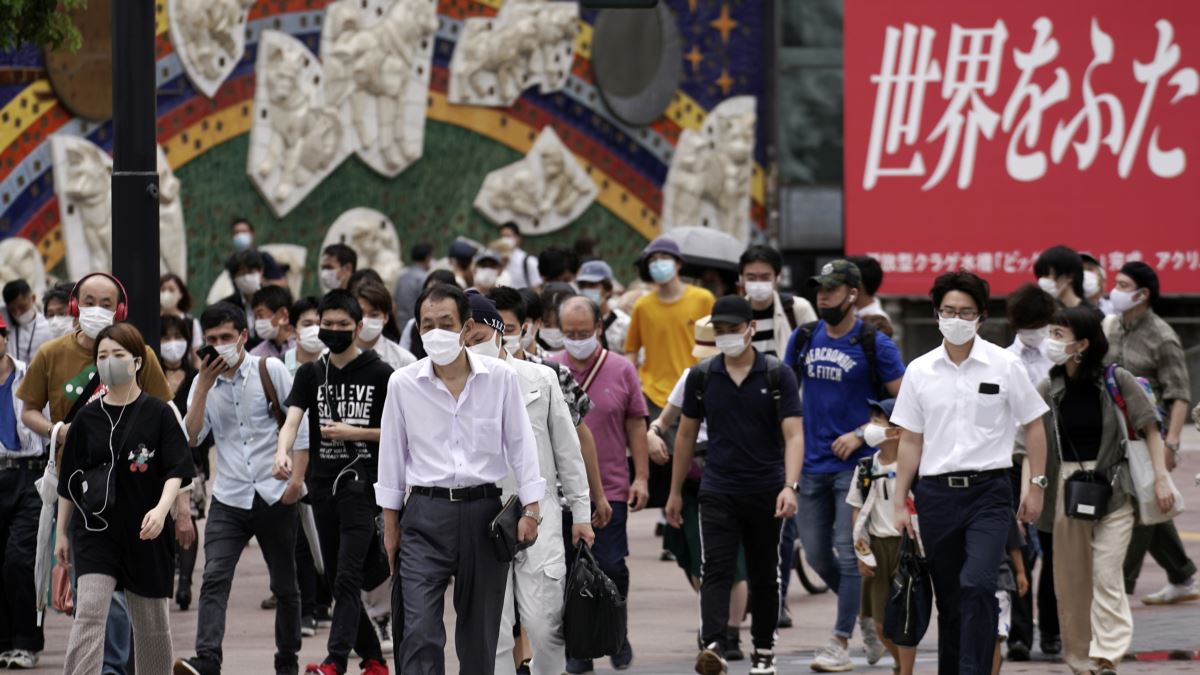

{"left": 313, "top": 480, "right": 383, "bottom": 673}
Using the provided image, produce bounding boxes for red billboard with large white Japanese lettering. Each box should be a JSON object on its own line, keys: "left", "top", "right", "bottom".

{"left": 845, "top": 0, "right": 1200, "bottom": 294}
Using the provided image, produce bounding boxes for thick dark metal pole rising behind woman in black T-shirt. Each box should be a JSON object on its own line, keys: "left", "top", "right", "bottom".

{"left": 112, "top": 0, "right": 160, "bottom": 351}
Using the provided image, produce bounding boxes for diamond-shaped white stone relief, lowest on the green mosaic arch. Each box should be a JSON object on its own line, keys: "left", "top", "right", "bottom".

{"left": 475, "top": 126, "right": 600, "bottom": 234}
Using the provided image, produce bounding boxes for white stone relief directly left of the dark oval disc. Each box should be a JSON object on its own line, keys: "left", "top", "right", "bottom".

{"left": 449, "top": 0, "right": 580, "bottom": 107}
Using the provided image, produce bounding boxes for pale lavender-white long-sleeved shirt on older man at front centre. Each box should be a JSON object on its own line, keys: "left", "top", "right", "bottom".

{"left": 376, "top": 351, "right": 546, "bottom": 510}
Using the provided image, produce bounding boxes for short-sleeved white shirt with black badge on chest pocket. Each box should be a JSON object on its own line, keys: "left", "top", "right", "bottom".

{"left": 892, "top": 338, "right": 1049, "bottom": 476}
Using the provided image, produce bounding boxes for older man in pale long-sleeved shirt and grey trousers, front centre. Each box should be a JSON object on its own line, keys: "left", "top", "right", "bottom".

{"left": 376, "top": 285, "right": 546, "bottom": 675}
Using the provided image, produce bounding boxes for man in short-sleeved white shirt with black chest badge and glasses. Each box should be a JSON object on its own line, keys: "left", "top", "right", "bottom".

{"left": 892, "top": 271, "right": 1048, "bottom": 675}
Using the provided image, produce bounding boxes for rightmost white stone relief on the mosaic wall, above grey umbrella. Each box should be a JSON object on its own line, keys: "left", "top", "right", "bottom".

{"left": 662, "top": 96, "right": 756, "bottom": 244}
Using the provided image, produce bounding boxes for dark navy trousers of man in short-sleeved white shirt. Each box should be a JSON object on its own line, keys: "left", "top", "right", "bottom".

{"left": 913, "top": 478, "right": 1015, "bottom": 675}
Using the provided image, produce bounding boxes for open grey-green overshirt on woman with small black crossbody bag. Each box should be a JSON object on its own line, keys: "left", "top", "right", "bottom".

{"left": 1037, "top": 368, "right": 1158, "bottom": 532}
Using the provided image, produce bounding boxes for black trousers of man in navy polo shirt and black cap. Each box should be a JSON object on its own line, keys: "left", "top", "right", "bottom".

{"left": 700, "top": 490, "right": 784, "bottom": 650}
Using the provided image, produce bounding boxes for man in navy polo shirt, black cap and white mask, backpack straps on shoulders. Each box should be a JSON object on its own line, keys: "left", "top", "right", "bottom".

{"left": 667, "top": 295, "right": 804, "bottom": 675}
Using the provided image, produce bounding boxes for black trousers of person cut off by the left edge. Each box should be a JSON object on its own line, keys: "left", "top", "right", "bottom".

{"left": 0, "top": 468, "right": 43, "bottom": 652}
